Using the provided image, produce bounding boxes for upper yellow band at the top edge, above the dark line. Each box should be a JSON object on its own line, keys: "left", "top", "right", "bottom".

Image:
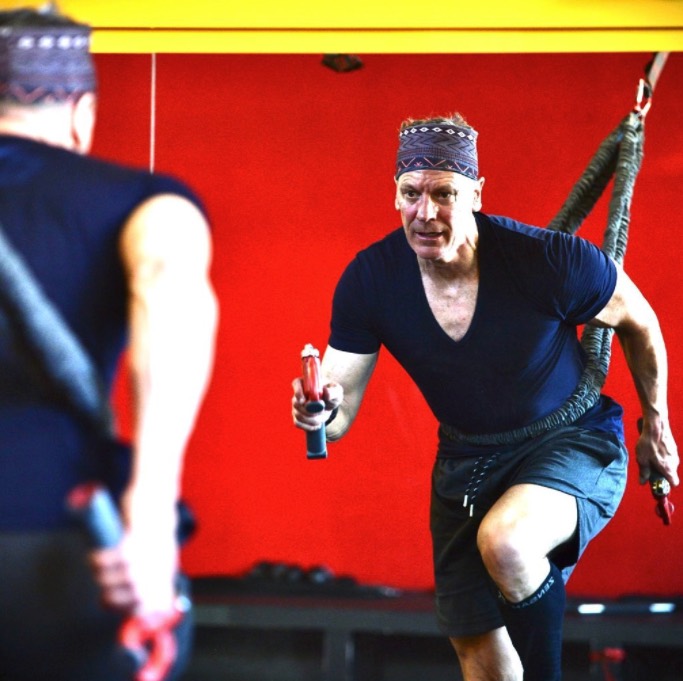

{"left": 12, "top": 0, "right": 683, "bottom": 29}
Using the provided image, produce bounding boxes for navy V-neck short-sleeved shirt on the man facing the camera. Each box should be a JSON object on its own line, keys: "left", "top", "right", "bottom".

{"left": 329, "top": 213, "right": 622, "bottom": 446}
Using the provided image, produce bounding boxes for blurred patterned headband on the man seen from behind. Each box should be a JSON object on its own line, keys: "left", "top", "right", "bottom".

{"left": 0, "top": 13, "right": 96, "bottom": 104}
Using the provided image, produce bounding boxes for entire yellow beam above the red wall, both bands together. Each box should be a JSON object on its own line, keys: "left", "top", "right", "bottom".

{"left": 1, "top": 0, "right": 683, "bottom": 53}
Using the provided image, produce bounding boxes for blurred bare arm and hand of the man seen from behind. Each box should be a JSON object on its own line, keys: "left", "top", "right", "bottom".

{"left": 96, "top": 195, "right": 217, "bottom": 614}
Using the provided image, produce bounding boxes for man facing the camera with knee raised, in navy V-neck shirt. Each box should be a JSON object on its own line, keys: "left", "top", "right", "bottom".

{"left": 292, "top": 115, "right": 678, "bottom": 681}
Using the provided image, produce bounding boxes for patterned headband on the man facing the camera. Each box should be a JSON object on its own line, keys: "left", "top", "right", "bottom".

{"left": 396, "top": 123, "right": 479, "bottom": 180}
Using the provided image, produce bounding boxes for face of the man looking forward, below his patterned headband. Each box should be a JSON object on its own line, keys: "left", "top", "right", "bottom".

{"left": 396, "top": 170, "right": 484, "bottom": 262}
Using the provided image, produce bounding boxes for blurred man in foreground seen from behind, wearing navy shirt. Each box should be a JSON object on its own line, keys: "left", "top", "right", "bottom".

{"left": 0, "top": 10, "right": 216, "bottom": 681}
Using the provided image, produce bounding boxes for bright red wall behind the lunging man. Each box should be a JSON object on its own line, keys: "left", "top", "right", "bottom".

{"left": 95, "top": 54, "right": 683, "bottom": 596}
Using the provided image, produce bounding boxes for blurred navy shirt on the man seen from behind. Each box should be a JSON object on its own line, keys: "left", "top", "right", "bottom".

{"left": 0, "top": 135, "right": 206, "bottom": 530}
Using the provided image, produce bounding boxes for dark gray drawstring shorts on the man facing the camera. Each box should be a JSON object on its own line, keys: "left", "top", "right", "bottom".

{"left": 430, "top": 426, "right": 628, "bottom": 637}
